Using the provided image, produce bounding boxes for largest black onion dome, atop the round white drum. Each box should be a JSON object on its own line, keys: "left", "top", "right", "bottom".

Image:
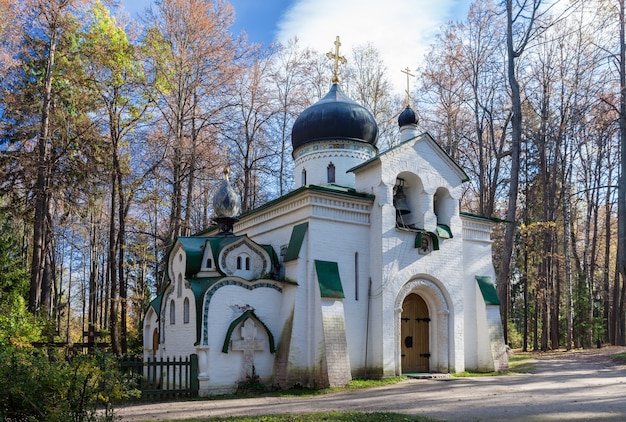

{"left": 291, "top": 83, "right": 378, "bottom": 151}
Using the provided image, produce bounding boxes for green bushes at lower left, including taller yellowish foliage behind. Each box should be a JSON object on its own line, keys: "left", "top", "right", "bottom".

{"left": 0, "top": 286, "right": 139, "bottom": 421}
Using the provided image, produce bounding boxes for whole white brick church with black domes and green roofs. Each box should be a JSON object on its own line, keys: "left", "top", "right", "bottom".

{"left": 144, "top": 40, "right": 508, "bottom": 395}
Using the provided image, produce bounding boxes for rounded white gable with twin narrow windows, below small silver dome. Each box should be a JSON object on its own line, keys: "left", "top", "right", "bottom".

{"left": 218, "top": 237, "right": 272, "bottom": 280}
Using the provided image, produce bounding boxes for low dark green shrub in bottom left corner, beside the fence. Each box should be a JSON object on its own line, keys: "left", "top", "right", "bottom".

{"left": 0, "top": 347, "right": 136, "bottom": 421}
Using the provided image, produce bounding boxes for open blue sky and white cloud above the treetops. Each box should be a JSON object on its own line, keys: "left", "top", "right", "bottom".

{"left": 121, "top": 0, "right": 471, "bottom": 92}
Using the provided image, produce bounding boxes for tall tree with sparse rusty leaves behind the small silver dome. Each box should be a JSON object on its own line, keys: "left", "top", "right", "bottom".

{"left": 144, "top": 0, "right": 238, "bottom": 251}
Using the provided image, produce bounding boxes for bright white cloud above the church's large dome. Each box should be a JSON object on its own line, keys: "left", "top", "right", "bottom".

{"left": 277, "top": 0, "right": 469, "bottom": 92}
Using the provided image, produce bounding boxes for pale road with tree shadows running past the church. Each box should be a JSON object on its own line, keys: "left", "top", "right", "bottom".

{"left": 116, "top": 347, "right": 626, "bottom": 421}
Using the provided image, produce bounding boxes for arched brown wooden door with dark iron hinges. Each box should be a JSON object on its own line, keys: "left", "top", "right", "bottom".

{"left": 400, "top": 293, "right": 430, "bottom": 374}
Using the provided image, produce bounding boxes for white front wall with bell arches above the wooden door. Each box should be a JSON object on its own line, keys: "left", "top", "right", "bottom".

{"left": 356, "top": 136, "right": 465, "bottom": 376}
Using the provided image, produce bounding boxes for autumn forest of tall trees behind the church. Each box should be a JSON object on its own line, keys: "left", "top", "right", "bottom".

{"left": 0, "top": 0, "right": 626, "bottom": 354}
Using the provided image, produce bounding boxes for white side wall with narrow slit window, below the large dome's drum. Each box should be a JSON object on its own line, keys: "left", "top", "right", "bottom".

{"left": 235, "top": 187, "right": 372, "bottom": 384}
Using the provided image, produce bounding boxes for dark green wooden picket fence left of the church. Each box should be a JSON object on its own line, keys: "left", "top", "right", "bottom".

{"left": 119, "top": 354, "right": 199, "bottom": 399}
